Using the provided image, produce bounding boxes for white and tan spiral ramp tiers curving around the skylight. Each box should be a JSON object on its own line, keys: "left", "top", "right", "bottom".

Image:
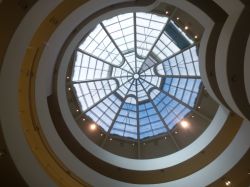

{"left": 0, "top": 0, "right": 250, "bottom": 187}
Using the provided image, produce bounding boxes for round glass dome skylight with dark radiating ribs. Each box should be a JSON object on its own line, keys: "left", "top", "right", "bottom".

{"left": 72, "top": 13, "right": 201, "bottom": 139}
